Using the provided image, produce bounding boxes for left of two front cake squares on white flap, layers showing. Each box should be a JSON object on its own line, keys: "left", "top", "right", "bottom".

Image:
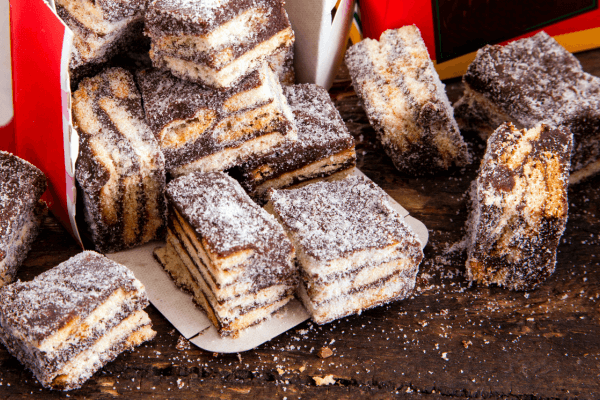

{"left": 155, "top": 172, "right": 298, "bottom": 336}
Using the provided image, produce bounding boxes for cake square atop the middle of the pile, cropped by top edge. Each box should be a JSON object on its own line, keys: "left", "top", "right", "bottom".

{"left": 145, "top": 0, "right": 294, "bottom": 88}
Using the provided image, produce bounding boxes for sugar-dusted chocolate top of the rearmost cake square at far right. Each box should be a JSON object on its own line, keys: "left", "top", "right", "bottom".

{"left": 464, "top": 32, "right": 600, "bottom": 128}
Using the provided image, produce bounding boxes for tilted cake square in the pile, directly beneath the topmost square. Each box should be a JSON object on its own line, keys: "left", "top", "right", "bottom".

{"left": 137, "top": 65, "right": 296, "bottom": 177}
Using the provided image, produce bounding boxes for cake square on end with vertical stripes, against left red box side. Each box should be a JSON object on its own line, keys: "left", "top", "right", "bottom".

{"left": 73, "top": 68, "right": 167, "bottom": 253}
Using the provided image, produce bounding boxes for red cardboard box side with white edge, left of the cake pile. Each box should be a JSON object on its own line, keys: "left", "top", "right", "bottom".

{"left": 6, "top": 0, "right": 79, "bottom": 239}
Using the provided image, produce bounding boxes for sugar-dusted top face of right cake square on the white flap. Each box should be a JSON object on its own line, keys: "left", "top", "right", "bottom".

{"left": 271, "top": 177, "right": 417, "bottom": 260}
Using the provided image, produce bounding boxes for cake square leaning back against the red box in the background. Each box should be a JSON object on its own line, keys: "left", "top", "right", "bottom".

{"left": 345, "top": 25, "right": 471, "bottom": 174}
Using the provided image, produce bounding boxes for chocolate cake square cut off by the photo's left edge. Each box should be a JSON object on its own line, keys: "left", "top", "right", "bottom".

{"left": 0, "top": 151, "right": 47, "bottom": 287}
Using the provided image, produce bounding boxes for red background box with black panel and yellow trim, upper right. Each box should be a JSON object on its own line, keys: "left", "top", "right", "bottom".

{"left": 360, "top": 0, "right": 600, "bottom": 79}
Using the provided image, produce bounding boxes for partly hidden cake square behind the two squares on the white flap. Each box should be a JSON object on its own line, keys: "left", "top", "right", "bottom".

{"left": 241, "top": 84, "right": 356, "bottom": 200}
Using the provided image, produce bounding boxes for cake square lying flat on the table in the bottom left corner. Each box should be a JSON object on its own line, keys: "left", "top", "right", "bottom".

{"left": 0, "top": 251, "right": 156, "bottom": 390}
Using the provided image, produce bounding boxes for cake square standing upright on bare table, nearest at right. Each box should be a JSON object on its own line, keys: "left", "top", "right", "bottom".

{"left": 467, "top": 123, "right": 573, "bottom": 290}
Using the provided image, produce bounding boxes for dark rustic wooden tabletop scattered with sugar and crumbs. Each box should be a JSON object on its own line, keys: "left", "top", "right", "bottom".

{"left": 0, "top": 50, "right": 600, "bottom": 399}
